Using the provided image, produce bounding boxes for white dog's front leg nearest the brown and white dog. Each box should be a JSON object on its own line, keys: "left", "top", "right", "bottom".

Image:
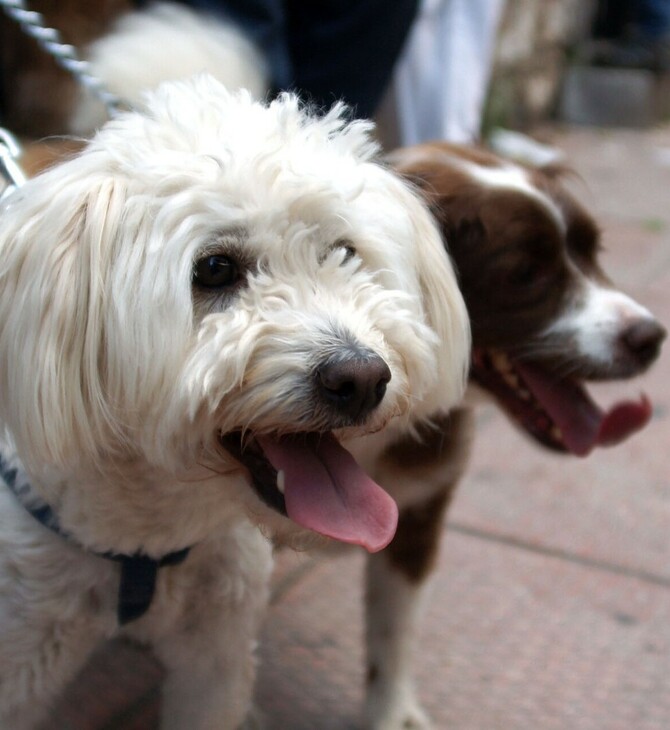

{"left": 154, "top": 526, "right": 272, "bottom": 730}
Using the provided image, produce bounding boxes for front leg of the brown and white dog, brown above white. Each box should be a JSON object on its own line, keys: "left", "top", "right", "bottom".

{"left": 365, "top": 410, "right": 472, "bottom": 730}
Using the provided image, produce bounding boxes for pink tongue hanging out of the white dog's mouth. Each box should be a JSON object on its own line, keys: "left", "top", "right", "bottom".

{"left": 258, "top": 434, "right": 398, "bottom": 552}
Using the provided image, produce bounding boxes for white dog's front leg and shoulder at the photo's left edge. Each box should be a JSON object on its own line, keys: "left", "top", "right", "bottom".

{"left": 0, "top": 498, "right": 116, "bottom": 730}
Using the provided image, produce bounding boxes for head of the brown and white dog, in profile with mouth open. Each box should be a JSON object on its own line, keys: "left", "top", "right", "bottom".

{"left": 392, "top": 143, "right": 665, "bottom": 456}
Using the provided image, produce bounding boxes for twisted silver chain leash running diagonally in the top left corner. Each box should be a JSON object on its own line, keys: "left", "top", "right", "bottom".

{"left": 0, "top": 0, "right": 128, "bottom": 117}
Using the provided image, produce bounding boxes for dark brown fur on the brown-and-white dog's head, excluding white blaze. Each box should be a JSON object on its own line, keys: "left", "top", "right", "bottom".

{"left": 390, "top": 143, "right": 598, "bottom": 354}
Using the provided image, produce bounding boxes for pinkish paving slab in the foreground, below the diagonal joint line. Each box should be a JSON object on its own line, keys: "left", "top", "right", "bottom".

{"left": 259, "top": 531, "right": 670, "bottom": 730}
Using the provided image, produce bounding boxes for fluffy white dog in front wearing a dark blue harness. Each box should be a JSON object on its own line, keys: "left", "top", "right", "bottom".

{"left": 0, "top": 76, "right": 469, "bottom": 730}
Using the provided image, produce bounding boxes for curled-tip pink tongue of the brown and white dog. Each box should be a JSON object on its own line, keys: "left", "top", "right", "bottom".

{"left": 519, "top": 365, "right": 652, "bottom": 456}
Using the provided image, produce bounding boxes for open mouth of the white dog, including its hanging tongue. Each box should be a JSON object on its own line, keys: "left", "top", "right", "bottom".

{"left": 220, "top": 431, "right": 398, "bottom": 552}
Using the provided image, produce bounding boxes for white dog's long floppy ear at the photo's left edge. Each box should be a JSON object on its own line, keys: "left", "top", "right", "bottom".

{"left": 0, "top": 165, "right": 125, "bottom": 467}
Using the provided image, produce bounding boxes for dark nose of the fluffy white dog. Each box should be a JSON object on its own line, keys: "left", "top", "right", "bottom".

{"left": 316, "top": 347, "right": 391, "bottom": 422}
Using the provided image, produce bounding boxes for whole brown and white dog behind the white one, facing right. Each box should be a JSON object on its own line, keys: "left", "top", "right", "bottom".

{"left": 352, "top": 143, "right": 666, "bottom": 728}
